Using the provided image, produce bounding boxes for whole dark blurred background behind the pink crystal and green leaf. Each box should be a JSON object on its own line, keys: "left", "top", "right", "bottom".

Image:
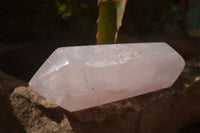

{"left": 0, "top": 0, "right": 200, "bottom": 81}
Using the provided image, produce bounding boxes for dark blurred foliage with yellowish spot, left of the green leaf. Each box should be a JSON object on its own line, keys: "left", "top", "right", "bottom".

{"left": 0, "top": 0, "right": 98, "bottom": 39}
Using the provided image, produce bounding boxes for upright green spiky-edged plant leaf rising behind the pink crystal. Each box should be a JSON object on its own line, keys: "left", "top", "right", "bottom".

{"left": 96, "top": 0, "right": 127, "bottom": 44}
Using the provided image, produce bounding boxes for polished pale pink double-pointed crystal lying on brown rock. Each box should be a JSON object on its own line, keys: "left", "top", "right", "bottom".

{"left": 29, "top": 43, "right": 185, "bottom": 111}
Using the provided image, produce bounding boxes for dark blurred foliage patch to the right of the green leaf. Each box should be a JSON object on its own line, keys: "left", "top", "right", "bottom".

{"left": 123, "top": 0, "right": 184, "bottom": 34}
